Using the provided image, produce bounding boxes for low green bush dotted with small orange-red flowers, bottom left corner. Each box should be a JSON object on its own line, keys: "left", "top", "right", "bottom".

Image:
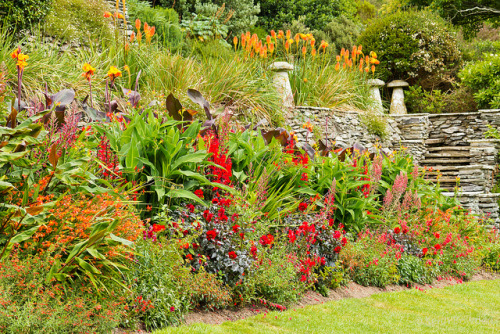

{"left": 0, "top": 248, "right": 126, "bottom": 334}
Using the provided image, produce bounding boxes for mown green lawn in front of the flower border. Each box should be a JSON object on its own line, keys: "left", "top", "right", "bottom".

{"left": 155, "top": 280, "right": 500, "bottom": 334}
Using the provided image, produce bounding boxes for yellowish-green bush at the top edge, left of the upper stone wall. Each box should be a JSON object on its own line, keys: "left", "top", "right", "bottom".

{"left": 42, "top": 0, "right": 112, "bottom": 43}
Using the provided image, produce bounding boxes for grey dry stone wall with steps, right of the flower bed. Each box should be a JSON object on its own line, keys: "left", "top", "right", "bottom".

{"left": 288, "top": 107, "right": 500, "bottom": 224}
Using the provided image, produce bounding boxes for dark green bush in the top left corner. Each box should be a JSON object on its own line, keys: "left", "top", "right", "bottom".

{"left": 0, "top": 0, "right": 52, "bottom": 30}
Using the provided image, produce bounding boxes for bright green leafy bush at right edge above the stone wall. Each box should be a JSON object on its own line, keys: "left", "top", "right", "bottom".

{"left": 459, "top": 53, "right": 500, "bottom": 109}
